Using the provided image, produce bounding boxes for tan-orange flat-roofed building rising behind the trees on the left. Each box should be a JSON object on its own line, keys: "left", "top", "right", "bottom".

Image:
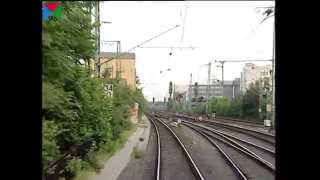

{"left": 100, "top": 52, "right": 136, "bottom": 89}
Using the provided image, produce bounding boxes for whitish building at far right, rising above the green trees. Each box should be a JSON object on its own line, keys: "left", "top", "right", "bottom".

{"left": 240, "top": 63, "right": 272, "bottom": 93}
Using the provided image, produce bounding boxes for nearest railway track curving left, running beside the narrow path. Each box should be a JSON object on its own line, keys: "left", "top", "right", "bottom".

{"left": 147, "top": 114, "right": 204, "bottom": 180}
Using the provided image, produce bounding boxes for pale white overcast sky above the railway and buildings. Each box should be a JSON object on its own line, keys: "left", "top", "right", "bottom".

{"left": 100, "top": 1, "right": 275, "bottom": 101}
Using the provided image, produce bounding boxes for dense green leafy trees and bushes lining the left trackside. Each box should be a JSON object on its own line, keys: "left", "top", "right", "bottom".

{"left": 42, "top": 1, "right": 146, "bottom": 179}
